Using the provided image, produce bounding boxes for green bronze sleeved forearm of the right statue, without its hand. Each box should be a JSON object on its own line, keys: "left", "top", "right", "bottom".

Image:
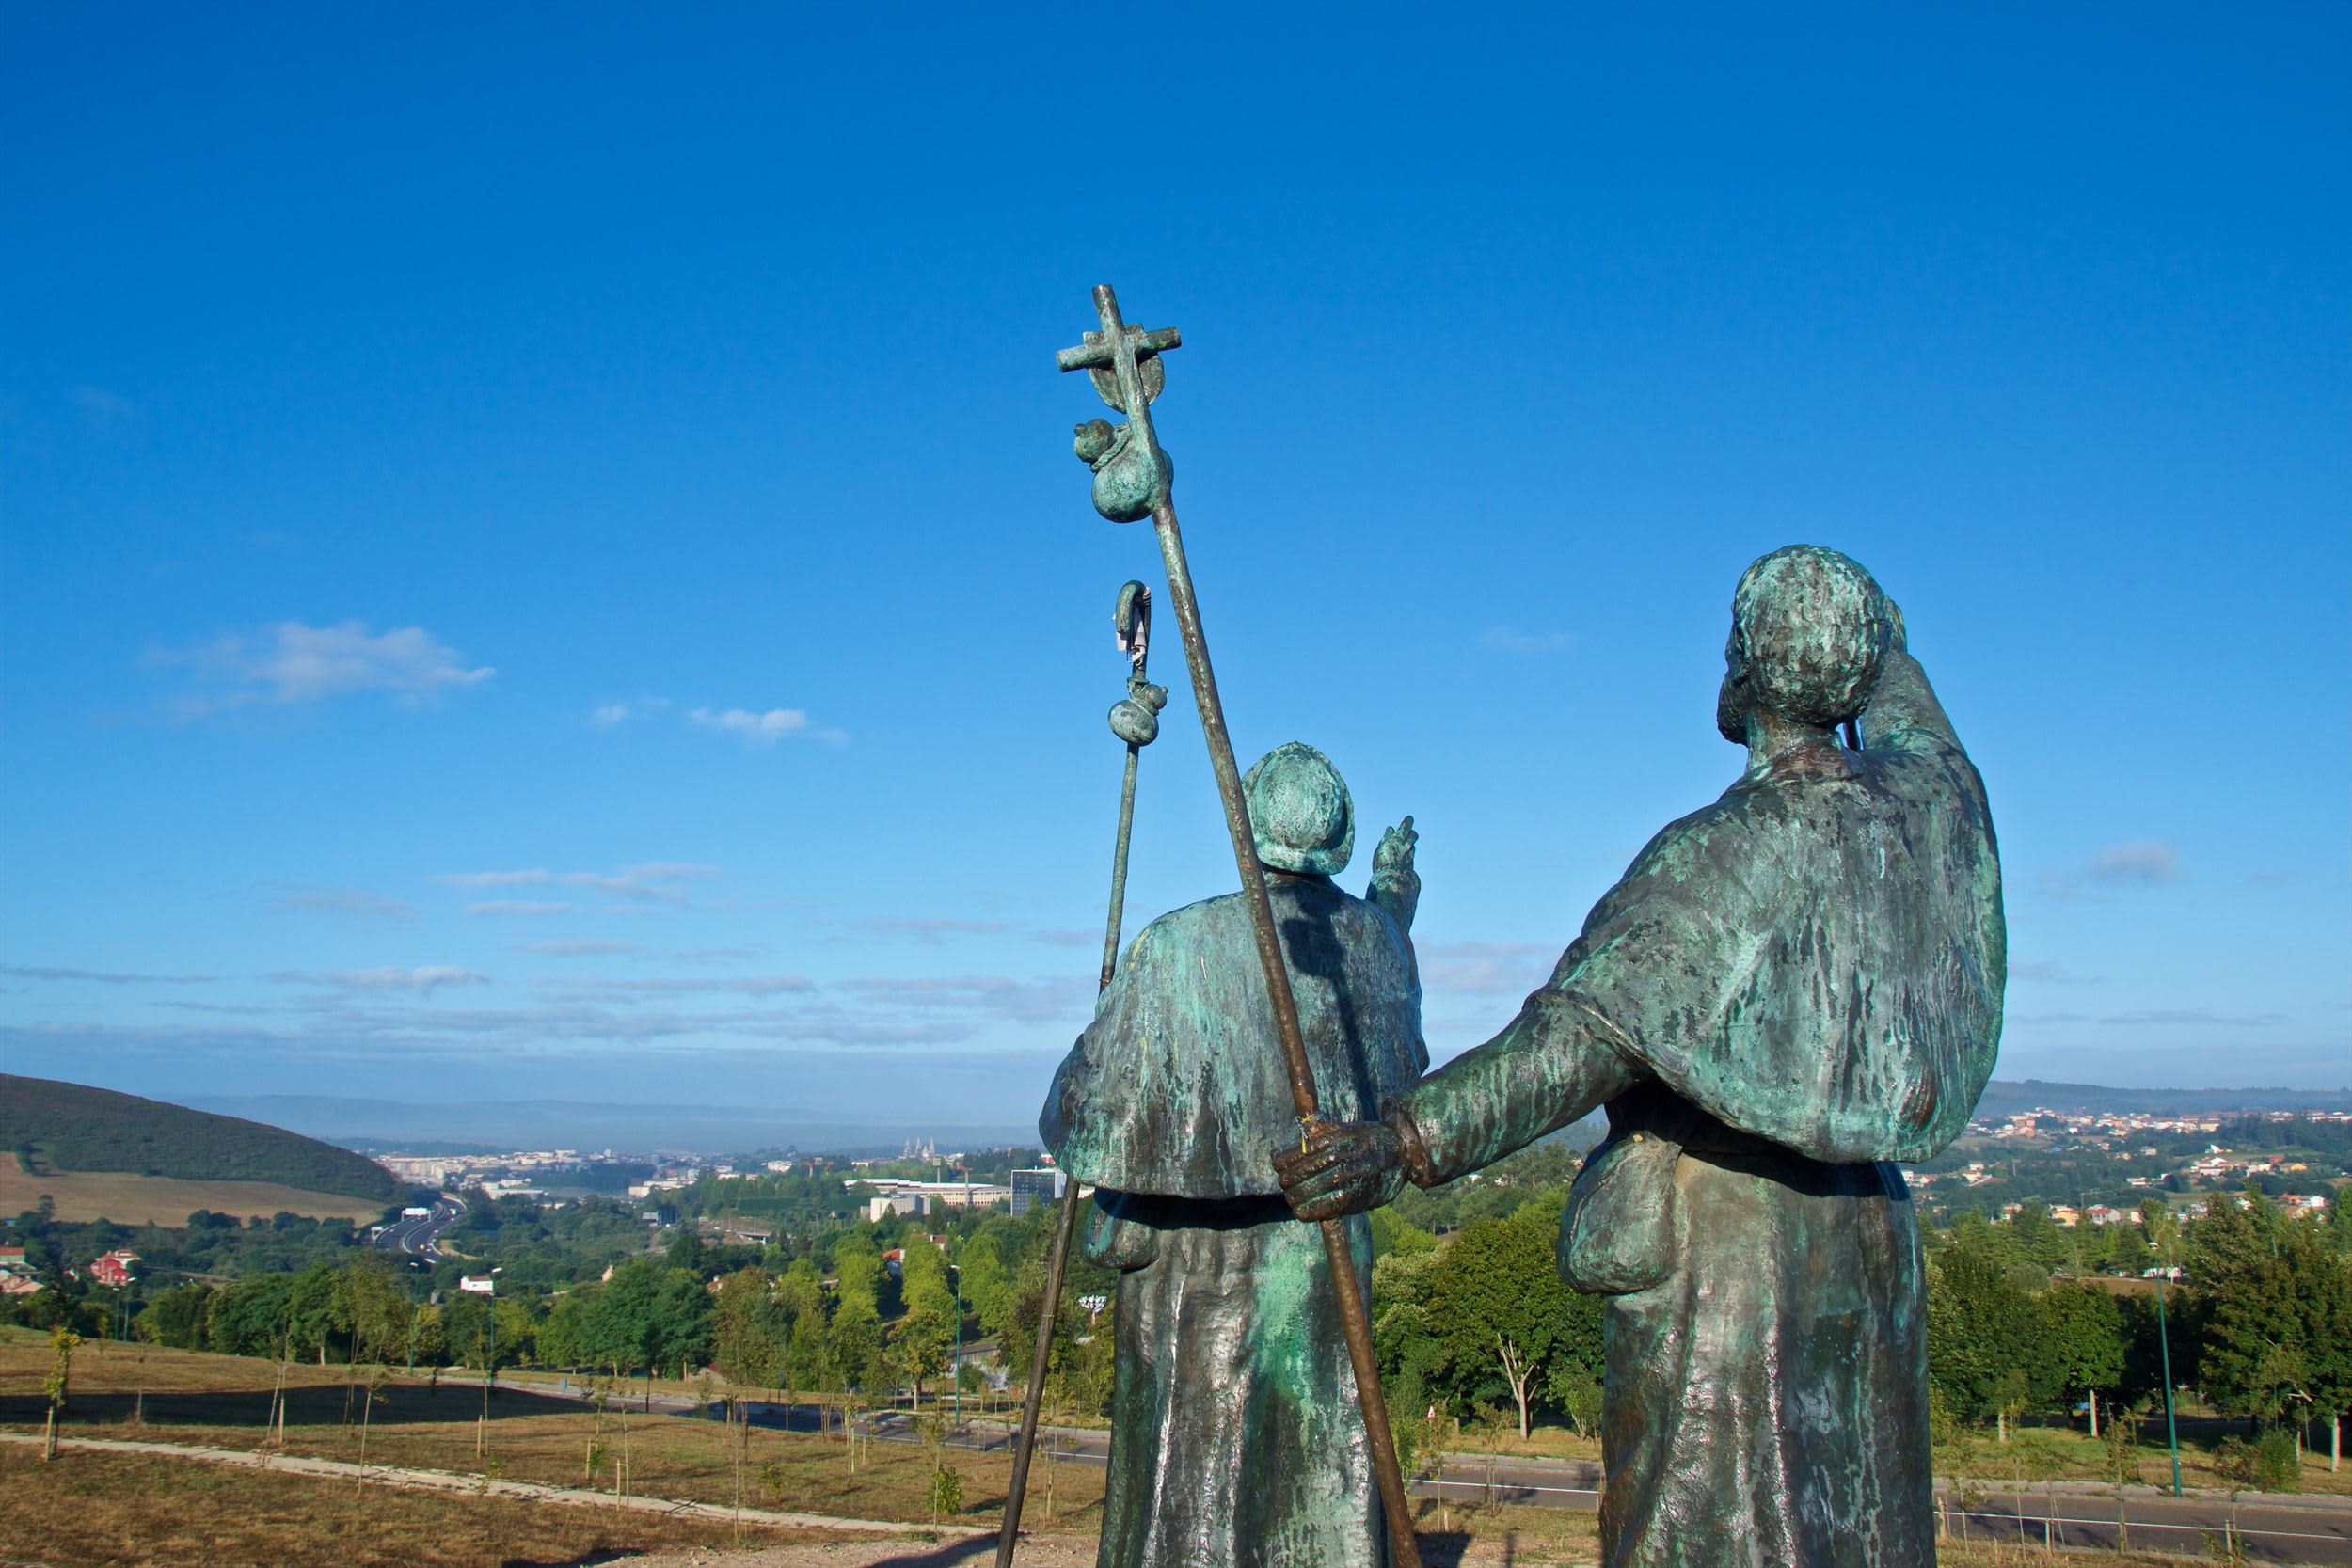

{"left": 1391, "top": 988, "right": 1645, "bottom": 1187}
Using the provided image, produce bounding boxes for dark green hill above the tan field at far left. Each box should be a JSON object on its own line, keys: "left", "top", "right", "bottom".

{"left": 0, "top": 1074, "right": 400, "bottom": 1204}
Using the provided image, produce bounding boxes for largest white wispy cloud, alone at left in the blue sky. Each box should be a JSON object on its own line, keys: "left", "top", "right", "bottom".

{"left": 160, "top": 621, "right": 494, "bottom": 717}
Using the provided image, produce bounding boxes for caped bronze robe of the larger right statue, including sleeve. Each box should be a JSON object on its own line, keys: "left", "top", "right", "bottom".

{"left": 1400, "top": 651, "right": 2007, "bottom": 1568}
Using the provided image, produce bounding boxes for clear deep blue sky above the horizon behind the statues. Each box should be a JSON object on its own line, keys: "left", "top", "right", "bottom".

{"left": 0, "top": 5, "right": 2352, "bottom": 1126}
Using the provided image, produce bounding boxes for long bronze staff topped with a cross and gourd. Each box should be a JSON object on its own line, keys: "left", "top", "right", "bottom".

{"left": 1057, "top": 284, "right": 1421, "bottom": 1568}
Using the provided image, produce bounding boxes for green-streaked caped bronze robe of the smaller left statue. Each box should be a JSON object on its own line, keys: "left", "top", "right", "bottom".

{"left": 1038, "top": 877, "right": 1428, "bottom": 1568}
